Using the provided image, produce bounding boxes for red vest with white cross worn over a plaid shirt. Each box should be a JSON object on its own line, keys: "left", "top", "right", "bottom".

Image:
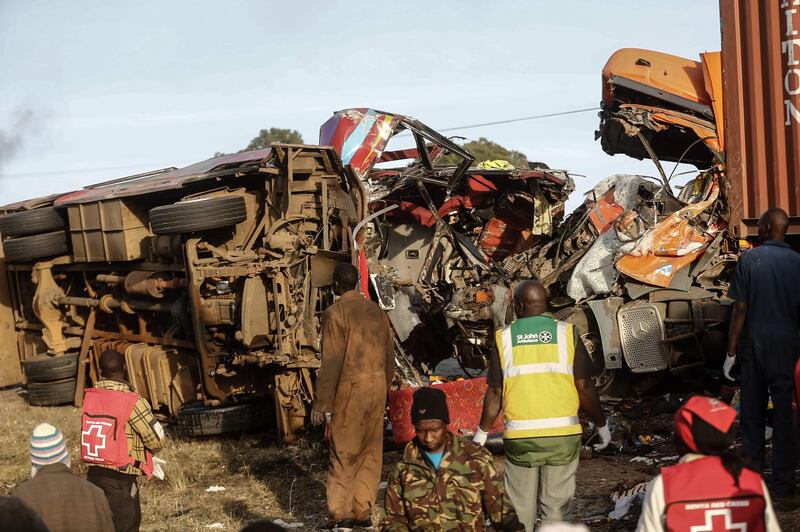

{"left": 81, "top": 388, "right": 153, "bottom": 479}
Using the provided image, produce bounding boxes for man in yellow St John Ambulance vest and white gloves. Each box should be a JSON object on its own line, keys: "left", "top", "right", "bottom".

{"left": 474, "top": 281, "right": 611, "bottom": 532}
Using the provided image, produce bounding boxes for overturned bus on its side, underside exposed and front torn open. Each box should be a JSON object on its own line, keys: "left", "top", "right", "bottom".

{"left": 0, "top": 109, "right": 572, "bottom": 440}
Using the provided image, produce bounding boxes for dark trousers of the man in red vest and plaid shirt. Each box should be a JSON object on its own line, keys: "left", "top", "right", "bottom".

{"left": 87, "top": 466, "right": 142, "bottom": 532}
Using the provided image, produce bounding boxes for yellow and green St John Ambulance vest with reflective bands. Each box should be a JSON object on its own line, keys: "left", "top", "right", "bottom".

{"left": 495, "top": 315, "right": 582, "bottom": 439}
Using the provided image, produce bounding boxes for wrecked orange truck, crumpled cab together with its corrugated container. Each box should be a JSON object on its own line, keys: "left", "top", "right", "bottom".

{"left": 551, "top": 1, "right": 800, "bottom": 394}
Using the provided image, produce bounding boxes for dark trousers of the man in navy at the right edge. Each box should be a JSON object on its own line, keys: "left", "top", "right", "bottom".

{"left": 739, "top": 331, "right": 800, "bottom": 497}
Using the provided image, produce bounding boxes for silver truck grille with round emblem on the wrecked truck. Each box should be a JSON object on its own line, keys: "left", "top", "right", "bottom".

{"left": 617, "top": 305, "right": 668, "bottom": 373}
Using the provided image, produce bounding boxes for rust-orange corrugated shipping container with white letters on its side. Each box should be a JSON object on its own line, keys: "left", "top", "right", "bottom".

{"left": 720, "top": 0, "right": 800, "bottom": 236}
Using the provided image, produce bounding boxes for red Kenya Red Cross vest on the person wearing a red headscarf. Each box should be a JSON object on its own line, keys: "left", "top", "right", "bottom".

{"left": 661, "top": 456, "right": 766, "bottom": 532}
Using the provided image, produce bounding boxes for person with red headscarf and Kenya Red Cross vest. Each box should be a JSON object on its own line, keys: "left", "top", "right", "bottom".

{"left": 637, "top": 395, "right": 780, "bottom": 532}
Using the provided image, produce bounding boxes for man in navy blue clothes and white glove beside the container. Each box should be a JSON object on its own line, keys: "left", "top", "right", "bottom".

{"left": 724, "top": 209, "right": 800, "bottom": 498}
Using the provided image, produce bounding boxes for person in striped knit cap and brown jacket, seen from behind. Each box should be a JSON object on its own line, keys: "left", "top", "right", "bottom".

{"left": 11, "top": 423, "right": 114, "bottom": 532}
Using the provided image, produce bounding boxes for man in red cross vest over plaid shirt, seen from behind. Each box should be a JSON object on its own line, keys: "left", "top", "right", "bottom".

{"left": 81, "top": 349, "right": 164, "bottom": 532}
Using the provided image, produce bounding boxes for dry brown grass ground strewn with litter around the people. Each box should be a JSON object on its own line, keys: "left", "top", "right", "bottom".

{"left": 0, "top": 390, "right": 800, "bottom": 531}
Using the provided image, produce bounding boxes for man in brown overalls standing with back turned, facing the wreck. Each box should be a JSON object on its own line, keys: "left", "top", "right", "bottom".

{"left": 311, "top": 264, "right": 394, "bottom": 530}
